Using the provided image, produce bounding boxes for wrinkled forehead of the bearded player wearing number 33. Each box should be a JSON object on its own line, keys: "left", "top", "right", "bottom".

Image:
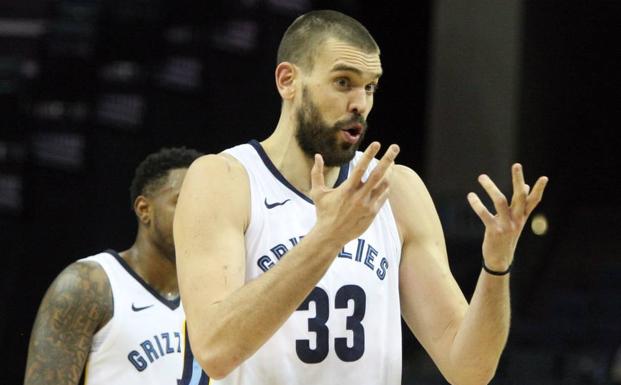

{"left": 315, "top": 38, "right": 382, "bottom": 78}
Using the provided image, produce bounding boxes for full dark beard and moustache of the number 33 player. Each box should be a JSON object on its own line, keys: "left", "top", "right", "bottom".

{"left": 295, "top": 87, "right": 367, "bottom": 167}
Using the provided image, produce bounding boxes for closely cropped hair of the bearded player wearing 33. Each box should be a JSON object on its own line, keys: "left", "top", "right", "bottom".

{"left": 276, "top": 10, "right": 380, "bottom": 71}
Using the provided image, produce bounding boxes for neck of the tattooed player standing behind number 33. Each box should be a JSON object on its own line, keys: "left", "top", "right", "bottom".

{"left": 120, "top": 234, "right": 179, "bottom": 300}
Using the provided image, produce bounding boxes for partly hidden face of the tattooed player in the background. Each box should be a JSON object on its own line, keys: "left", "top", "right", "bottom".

{"left": 148, "top": 168, "right": 188, "bottom": 262}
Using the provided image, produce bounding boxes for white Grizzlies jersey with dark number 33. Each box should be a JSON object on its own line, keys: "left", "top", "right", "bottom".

{"left": 218, "top": 141, "right": 402, "bottom": 385}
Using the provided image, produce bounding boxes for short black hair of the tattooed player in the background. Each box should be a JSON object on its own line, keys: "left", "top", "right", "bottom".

{"left": 129, "top": 147, "right": 203, "bottom": 207}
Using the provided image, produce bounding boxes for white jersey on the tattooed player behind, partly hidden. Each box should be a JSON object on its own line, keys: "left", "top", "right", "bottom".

{"left": 81, "top": 250, "right": 185, "bottom": 385}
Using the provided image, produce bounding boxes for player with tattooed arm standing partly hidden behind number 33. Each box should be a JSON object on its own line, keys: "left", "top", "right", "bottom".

{"left": 25, "top": 148, "right": 201, "bottom": 385}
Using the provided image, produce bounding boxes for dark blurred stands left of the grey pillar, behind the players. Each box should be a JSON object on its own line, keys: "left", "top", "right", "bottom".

{"left": 0, "top": 0, "right": 429, "bottom": 384}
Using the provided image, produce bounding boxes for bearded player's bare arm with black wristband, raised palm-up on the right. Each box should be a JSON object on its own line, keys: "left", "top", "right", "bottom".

{"left": 390, "top": 165, "right": 547, "bottom": 385}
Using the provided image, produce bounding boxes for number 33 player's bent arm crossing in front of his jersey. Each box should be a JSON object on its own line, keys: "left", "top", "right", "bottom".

{"left": 174, "top": 143, "right": 398, "bottom": 379}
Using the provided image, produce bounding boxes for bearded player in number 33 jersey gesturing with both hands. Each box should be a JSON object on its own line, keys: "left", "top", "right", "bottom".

{"left": 174, "top": 11, "right": 547, "bottom": 385}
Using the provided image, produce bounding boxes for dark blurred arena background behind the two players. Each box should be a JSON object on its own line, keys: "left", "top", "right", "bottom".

{"left": 0, "top": 0, "right": 621, "bottom": 385}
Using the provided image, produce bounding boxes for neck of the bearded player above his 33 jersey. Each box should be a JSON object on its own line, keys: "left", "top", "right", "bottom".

{"left": 261, "top": 114, "right": 340, "bottom": 195}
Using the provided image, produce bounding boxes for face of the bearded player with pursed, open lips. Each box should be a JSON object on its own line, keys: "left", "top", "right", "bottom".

{"left": 295, "top": 39, "right": 382, "bottom": 167}
